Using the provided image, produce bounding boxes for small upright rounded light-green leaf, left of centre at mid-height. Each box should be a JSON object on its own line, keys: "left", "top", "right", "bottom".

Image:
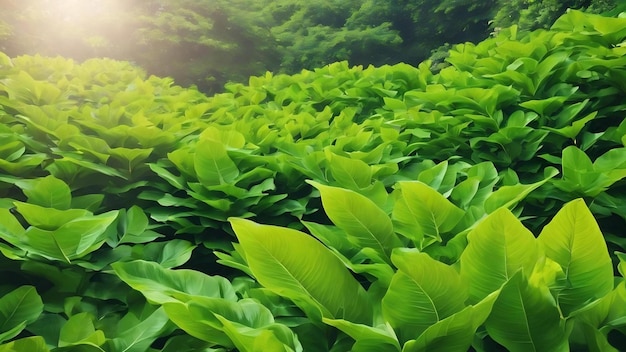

{"left": 194, "top": 140, "right": 239, "bottom": 186}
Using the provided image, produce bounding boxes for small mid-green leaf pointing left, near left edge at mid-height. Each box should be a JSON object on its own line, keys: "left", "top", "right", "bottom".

{"left": 15, "top": 175, "right": 72, "bottom": 210}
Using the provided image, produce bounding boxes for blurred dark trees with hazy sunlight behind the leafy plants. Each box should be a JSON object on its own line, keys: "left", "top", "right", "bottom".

{"left": 0, "top": 0, "right": 619, "bottom": 92}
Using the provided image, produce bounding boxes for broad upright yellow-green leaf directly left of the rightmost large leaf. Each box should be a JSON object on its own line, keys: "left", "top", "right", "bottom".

{"left": 460, "top": 208, "right": 539, "bottom": 302}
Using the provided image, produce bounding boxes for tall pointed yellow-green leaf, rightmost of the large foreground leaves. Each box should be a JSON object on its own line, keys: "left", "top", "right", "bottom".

{"left": 538, "top": 199, "right": 613, "bottom": 316}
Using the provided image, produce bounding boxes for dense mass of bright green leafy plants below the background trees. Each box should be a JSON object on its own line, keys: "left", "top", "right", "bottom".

{"left": 0, "top": 11, "right": 626, "bottom": 352}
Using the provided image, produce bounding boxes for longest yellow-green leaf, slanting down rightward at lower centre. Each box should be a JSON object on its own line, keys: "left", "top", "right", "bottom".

{"left": 229, "top": 218, "right": 372, "bottom": 323}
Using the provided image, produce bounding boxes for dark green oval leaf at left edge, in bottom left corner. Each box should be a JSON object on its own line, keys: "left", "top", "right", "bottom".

{"left": 0, "top": 286, "right": 43, "bottom": 343}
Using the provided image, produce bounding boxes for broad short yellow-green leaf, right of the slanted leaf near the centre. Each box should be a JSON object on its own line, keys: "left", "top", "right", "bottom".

{"left": 392, "top": 181, "right": 465, "bottom": 248}
